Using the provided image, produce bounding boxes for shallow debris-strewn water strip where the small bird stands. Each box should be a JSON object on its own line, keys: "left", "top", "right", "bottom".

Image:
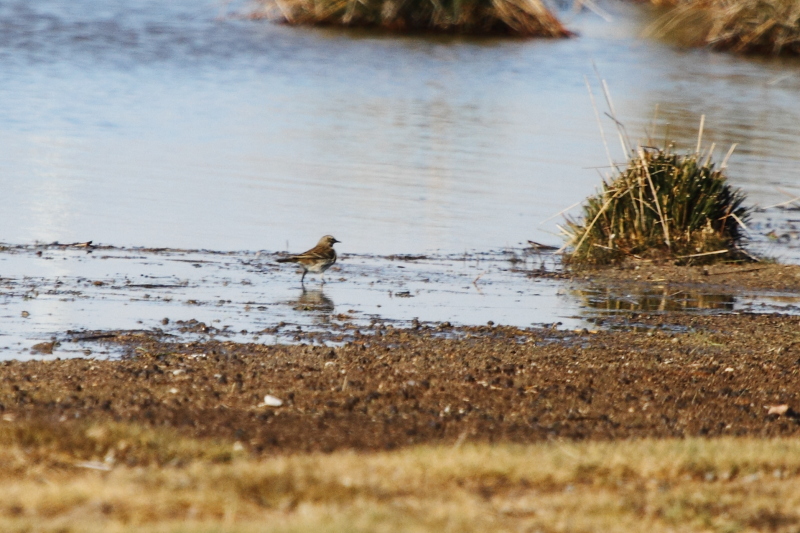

{"left": 0, "top": 246, "right": 800, "bottom": 360}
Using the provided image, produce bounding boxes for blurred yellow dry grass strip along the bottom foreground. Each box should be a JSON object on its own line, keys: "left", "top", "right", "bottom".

{"left": 0, "top": 422, "right": 800, "bottom": 533}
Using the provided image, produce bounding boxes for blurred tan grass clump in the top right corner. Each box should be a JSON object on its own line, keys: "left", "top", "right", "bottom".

{"left": 648, "top": 0, "right": 800, "bottom": 55}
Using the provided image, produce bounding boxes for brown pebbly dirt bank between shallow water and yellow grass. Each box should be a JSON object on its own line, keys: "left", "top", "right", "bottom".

{"left": 0, "top": 315, "right": 800, "bottom": 459}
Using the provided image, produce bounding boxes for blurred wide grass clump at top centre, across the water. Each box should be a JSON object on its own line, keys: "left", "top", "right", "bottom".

{"left": 253, "top": 0, "right": 571, "bottom": 37}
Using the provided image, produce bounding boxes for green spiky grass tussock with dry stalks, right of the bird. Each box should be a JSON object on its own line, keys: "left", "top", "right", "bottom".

{"left": 562, "top": 131, "right": 751, "bottom": 266}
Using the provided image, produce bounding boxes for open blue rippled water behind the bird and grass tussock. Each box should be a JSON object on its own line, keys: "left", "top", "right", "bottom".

{"left": 0, "top": 0, "right": 800, "bottom": 260}
